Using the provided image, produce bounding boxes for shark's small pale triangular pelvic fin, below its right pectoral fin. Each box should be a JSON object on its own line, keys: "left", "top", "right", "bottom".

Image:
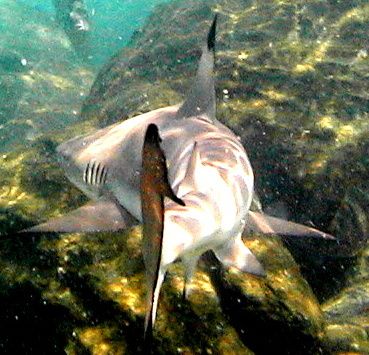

{"left": 214, "top": 235, "right": 265, "bottom": 276}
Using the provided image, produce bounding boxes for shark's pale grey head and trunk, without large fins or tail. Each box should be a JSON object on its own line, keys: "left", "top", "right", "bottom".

{"left": 58, "top": 102, "right": 253, "bottom": 264}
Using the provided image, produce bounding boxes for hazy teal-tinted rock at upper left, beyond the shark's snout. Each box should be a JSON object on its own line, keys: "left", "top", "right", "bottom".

{"left": 0, "top": 0, "right": 94, "bottom": 152}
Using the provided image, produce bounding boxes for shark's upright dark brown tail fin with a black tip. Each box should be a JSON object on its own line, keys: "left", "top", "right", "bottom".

{"left": 140, "top": 124, "right": 184, "bottom": 352}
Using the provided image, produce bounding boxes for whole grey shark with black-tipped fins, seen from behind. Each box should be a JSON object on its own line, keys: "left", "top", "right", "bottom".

{"left": 26, "top": 17, "right": 332, "bottom": 354}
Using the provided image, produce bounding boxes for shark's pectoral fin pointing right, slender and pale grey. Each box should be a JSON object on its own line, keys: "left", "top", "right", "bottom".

{"left": 244, "top": 211, "right": 335, "bottom": 240}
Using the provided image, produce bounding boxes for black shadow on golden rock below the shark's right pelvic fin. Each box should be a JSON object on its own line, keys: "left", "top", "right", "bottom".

{"left": 206, "top": 253, "right": 323, "bottom": 355}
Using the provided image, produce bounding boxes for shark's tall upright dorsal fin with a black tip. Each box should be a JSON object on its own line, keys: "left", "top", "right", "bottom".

{"left": 177, "top": 15, "right": 217, "bottom": 122}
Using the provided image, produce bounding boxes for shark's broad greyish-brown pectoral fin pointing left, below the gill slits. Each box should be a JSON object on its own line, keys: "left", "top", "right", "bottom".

{"left": 21, "top": 199, "right": 138, "bottom": 233}
